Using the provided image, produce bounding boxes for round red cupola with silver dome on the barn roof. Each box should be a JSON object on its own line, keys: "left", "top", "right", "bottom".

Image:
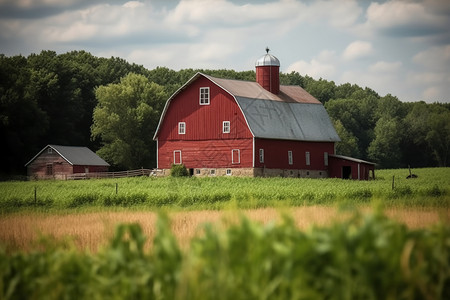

{"left": 255, "top": 48, "right": 280, "bottom": 94}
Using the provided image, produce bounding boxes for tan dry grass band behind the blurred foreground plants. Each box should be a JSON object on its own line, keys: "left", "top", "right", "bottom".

{"left": 0, "top": 206, "right": 450, "bottom": 252}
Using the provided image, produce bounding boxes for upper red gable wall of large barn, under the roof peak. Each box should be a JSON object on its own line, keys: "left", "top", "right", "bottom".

{"left": 158, "top": 76, "right": 252, "bottom": 141}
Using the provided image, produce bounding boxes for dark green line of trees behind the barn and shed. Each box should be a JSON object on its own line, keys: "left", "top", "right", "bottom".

{"left": 0, "top": 51, "right": 450, "bottom": 177}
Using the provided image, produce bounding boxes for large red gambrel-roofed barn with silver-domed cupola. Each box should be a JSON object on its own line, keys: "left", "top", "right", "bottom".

{"left": 154, "top": 49, "right": 356, "bottom": 177}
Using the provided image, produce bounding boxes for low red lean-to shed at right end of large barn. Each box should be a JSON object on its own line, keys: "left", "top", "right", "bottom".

{"left": 328, "top": 154, "right": 375, "bottom": 180}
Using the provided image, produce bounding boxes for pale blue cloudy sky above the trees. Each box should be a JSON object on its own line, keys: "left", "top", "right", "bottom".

{"left": 0, "top": 0, "right": 450, "bottom": 103}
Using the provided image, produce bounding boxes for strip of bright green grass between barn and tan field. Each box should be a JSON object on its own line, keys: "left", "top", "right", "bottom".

{"left": 0, "top": 168, "right": 450, "bottom": 213}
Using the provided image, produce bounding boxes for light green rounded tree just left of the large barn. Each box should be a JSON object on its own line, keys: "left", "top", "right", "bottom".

{"left": 91, "top": 73, "right": 167, "bottom": 169}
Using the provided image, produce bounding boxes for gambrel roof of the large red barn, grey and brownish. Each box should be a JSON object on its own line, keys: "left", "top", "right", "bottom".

{"left": 154, "top": 73, "right": 340, "bottom": 142}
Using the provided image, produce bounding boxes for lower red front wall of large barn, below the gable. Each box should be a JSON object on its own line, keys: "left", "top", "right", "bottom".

{"left": 158, "top": 139, "right": 253, "bottom": 169}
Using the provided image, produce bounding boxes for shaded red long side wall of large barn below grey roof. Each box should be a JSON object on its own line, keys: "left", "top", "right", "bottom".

{"left": 255, "top": 139, "right": 334, "bottom": 170}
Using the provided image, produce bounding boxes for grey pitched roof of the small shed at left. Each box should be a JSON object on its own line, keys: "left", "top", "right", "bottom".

{"left": 25, "top": 145, "right": 109, "bottom": 166}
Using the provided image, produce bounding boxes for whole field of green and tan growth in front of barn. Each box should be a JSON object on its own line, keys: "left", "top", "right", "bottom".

{"left": 0, "top": 168, "right": 450, "bottom": 299}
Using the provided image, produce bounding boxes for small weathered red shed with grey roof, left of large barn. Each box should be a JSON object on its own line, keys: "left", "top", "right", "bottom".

{"left": 25, "top": 145, "right": 109, "bottom": 179}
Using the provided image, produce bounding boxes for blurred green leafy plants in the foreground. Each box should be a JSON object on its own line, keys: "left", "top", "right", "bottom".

{"left": 0, "top": 214, "right": 450, "bottom": 299}
